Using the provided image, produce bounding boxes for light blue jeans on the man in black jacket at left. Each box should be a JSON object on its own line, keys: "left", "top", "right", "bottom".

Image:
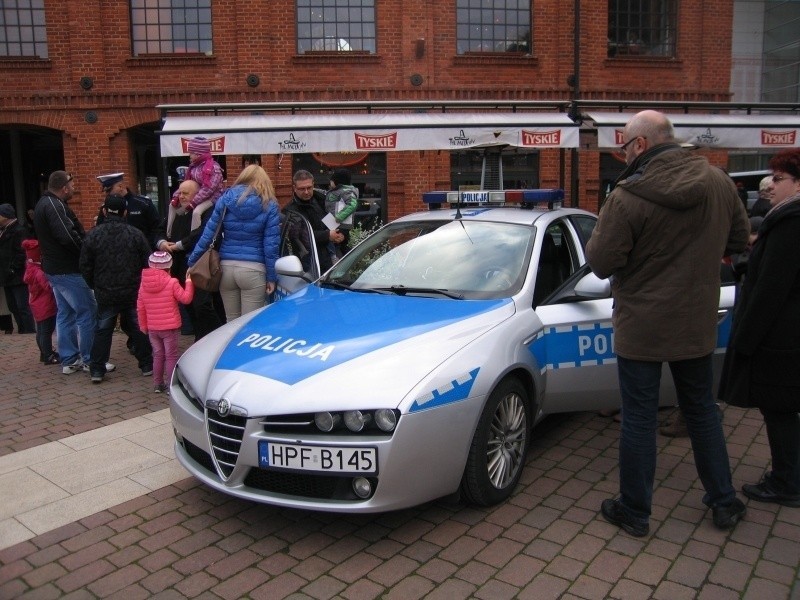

{"left": 47, "top": 273, "right": 97, "bottom": 365}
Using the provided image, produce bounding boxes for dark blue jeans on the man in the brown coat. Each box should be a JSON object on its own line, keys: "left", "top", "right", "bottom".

{"left": 617, "top": 354, "right": 736, "bottom": 524}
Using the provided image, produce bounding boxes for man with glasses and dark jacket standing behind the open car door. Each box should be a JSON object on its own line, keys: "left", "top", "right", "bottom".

{"left": 283, "top": 170, "right": 344, "bottom": 274}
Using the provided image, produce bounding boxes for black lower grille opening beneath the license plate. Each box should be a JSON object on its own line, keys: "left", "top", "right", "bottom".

{"left": 244, "top": 467, "right": 378, "bottom": 500}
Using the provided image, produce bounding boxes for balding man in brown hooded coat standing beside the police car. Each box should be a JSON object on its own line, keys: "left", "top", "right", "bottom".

{"left": 586, "top": 110, "right": 750, "bottom": 536}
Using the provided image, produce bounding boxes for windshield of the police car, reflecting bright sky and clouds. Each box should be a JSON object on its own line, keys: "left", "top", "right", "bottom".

{"left": 320, "top": 220, "right": 534, "bottom": 299}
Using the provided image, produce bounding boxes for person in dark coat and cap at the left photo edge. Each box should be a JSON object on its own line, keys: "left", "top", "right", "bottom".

{"left": 0, "top": 204, "right": 36, "bottom": 333}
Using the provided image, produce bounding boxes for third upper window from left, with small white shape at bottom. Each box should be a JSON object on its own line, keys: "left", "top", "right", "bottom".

{"left": 297, "top": 0, "right": 376, "bottom": 54}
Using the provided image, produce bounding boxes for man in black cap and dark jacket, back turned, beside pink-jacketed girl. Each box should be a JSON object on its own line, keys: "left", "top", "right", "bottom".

{"left": 80, "top": 194, "right": 153, "bottom": 383}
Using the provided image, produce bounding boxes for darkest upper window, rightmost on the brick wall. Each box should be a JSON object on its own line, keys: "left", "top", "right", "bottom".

{"left": 608, "top": 0, "right": 678, "bottom": 58}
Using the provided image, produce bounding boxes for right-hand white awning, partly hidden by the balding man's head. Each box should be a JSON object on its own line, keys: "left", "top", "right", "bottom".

{"left": 585, "top": 112, "right": 800, "bottom": 149}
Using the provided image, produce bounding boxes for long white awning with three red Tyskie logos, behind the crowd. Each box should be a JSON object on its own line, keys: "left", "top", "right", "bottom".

{"left": 159, "top": 112, "right": 579, "bottom": 157}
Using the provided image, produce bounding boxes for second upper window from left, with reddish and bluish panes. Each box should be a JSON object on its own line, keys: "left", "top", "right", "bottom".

{"left": 131, "top": 0, "right": 212, "bottom": 56}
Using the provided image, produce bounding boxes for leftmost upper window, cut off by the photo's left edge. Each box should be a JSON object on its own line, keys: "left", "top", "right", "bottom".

{"left": 0, "top": 0, "right": 47, "bottom": 58}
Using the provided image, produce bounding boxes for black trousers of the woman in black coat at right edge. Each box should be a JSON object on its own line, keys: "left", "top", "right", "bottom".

{"left": 759, "top": 408, "right": 800, "bottom": 494}
